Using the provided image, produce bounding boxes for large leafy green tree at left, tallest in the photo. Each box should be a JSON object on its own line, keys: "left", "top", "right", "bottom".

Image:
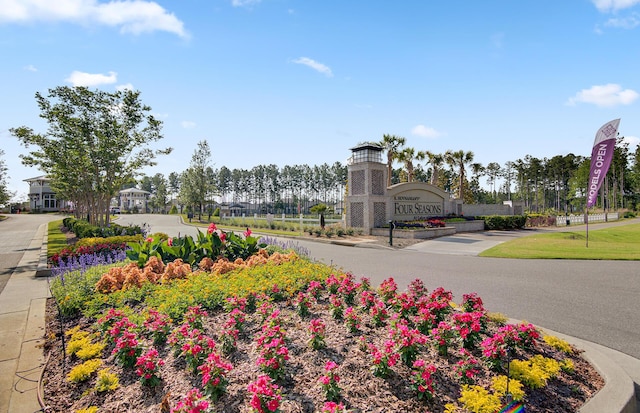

{"left": 10, "top": 86, "right": 171, "bottom": 226}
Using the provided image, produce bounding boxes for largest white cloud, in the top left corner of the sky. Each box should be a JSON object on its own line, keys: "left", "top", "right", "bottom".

{"left": 0, "top": 0, "right": 188, "bottom": 37}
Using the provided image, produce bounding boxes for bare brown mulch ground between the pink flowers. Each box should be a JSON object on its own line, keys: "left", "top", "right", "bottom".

{"left": 43, "top": 299, "right": 604, "bottom": 413}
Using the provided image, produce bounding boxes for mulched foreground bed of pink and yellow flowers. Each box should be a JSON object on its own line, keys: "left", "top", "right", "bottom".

{"left": 44, "top": 260, "right": 603, "bottom": 413}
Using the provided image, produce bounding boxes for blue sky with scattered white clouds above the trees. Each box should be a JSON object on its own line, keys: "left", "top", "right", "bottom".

{"left": 0, "top": 0, "right": 640, "bottom": 200}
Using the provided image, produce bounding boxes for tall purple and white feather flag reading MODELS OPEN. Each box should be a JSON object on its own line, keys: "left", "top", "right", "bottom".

{"left": 587, "top": 119, "right": 620, "bottom": 208}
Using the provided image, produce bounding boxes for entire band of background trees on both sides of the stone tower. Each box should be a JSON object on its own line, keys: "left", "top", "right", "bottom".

{"left": 10, "top": 87, "right": 640, "bottom": 225}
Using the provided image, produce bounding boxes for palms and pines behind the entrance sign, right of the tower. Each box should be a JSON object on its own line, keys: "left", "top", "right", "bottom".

{"left": 378, "top": 135, "right": 640, "bottom": 213}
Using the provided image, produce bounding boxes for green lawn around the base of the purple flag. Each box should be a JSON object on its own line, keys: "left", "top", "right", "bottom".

{"left": 480, "top": 220, "right": 640, "bottom": 260}
